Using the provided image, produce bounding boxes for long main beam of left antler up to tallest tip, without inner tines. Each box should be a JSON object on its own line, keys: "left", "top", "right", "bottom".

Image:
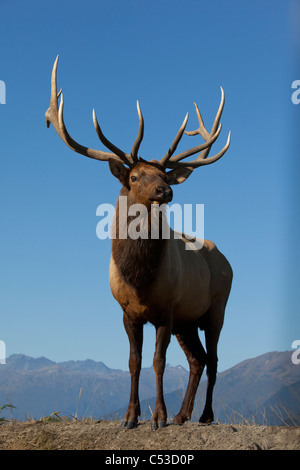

{"left": 45, "top": 56, "right": 130, "bottom": 165}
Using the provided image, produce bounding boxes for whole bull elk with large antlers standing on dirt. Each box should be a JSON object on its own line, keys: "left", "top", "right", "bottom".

{"left": 45, "top": 57, "right": 232, "bottom": 429}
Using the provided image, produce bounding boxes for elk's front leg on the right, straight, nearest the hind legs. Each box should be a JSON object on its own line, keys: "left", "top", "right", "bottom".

{"left": 151, "top": 321, "right": 172, "bottom": 430}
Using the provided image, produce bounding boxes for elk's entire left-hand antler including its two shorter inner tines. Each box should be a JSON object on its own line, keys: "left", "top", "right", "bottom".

{"left": 45, "top": 56, "right": 144, "bottom": 167}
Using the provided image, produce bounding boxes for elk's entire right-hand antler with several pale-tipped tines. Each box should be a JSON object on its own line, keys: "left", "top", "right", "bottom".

{"left": 159, "top": 87, "right": 230, "bottom": 169}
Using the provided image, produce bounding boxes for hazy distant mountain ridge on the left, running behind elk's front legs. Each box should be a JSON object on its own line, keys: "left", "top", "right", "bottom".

{"left": 0, "top": 354, "right": 188, "bottom": 420}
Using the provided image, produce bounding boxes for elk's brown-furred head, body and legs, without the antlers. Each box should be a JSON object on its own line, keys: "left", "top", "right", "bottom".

{"left": 110, "top": 162, "right": 232, "bottom": 428}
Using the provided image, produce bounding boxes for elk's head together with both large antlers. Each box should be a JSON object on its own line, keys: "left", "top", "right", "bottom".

{"left": 45, "top": 56, "right": 230, "bottom": 206}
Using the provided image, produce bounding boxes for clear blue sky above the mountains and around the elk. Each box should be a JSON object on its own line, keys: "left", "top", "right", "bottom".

{"left": 0, "top": 0, "right": 300, "bottom": 370}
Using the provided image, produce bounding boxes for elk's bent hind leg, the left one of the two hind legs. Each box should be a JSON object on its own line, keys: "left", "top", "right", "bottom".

{"left": 173, "top": 325, "right": 206, "bottom": 424}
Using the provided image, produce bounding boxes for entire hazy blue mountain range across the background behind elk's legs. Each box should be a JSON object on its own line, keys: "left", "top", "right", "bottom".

{"left": 0, "top": 351, "right": 300, "bottom": 425}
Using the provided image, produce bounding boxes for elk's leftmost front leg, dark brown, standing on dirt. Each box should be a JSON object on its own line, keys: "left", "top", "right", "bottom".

{"left": 122, "top": 312, "right": 143, "bottom": 429}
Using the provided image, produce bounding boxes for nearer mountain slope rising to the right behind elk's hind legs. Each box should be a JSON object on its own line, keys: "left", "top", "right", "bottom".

{"left": 115, "top": 351, "right": 300, "bottom": 425}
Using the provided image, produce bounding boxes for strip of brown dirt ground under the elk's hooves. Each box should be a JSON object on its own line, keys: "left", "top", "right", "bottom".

{"left": 0, "top": 420, "right": 300, "bottom": 451}
